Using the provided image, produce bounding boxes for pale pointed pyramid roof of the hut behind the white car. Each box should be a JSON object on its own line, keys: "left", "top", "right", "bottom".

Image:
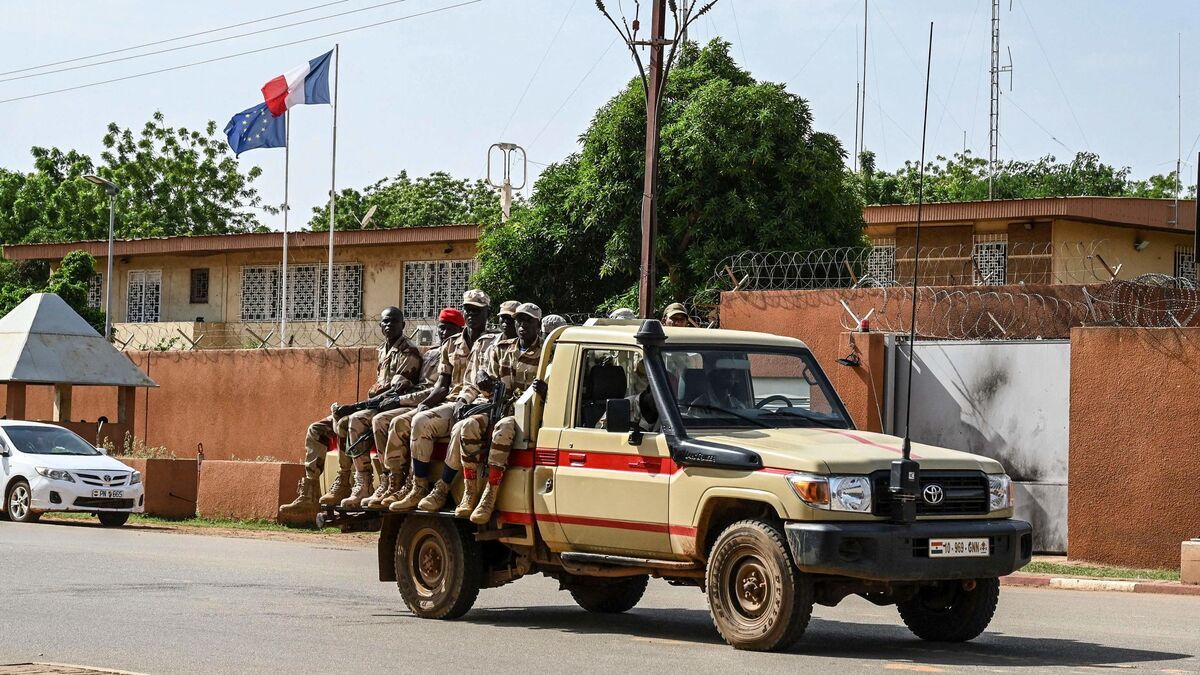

{"left": 0, "top": 293, "right": 157, "bottom": 387}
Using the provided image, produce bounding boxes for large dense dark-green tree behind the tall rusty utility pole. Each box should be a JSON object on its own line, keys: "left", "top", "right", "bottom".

{"left": 476, "top": 40, "right": 863, "bottom": 311}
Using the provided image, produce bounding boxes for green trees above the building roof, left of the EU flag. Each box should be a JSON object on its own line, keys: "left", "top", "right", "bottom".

{"left": 0, "top": 113, "right": 274, "bottom": 244}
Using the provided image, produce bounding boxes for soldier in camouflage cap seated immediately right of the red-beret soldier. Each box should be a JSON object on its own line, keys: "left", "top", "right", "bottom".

{"left": 388, "top": 289, "right": 492, "bottom": 512}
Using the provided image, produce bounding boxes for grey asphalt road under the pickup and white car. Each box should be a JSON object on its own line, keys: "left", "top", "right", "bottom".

{"left": 0, "top": 522, "right": 1200, "bottom": 674}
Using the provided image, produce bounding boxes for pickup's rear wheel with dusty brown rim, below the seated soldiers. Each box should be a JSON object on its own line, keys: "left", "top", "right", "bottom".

{"left": 395, "top": 514, "right": 484, "bottom": 619}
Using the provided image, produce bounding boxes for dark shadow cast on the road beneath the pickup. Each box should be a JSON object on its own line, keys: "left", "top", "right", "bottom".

{"left": 462, "top": 607, "right": 1194, "bottom": 668}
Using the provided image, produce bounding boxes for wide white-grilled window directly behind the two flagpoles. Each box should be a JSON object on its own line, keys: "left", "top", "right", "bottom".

{"left": 241, "top": 263, "right": 362, "bottom": 321}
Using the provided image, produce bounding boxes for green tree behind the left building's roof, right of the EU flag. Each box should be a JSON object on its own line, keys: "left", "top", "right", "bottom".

{"left": 308, "top": 171, "right": 500, "bottom": 231}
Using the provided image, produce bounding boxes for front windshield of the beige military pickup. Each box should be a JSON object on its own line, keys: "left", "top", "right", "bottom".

{"left": 662, "top": 347, "right": 851, "bottom": 429}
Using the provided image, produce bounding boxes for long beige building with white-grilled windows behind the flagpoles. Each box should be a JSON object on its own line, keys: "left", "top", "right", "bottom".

{"left": 4, "top": 225, "right": 479, "bottom": 348}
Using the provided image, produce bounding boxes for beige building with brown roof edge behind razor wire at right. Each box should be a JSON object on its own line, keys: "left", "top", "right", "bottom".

{"left": 863, "top": 197, "right": 1196, "bottom": 286}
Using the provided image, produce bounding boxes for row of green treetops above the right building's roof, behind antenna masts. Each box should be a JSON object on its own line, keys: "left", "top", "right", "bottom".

{"left": 856, "top": 150, "right": 1195, "bottom": 204}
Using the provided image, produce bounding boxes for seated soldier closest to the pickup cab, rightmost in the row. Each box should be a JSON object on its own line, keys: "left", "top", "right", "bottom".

{"left": 420, "top": 303, "right": 546, "bottom": 525}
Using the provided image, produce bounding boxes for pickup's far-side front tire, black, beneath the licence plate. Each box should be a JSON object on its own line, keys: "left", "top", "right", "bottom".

{"left": 896, "top": 571, "right": 1000, "bottom": 643}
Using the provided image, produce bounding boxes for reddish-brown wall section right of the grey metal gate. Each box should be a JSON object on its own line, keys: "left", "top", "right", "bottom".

{"left": 1068, "top": 327, "right": 1200, "bottom": 567}
